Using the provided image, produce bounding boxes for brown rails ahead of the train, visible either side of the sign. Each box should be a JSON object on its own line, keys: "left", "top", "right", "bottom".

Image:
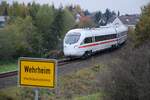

{"left": 0, "top": 59, "right": 72, "bottom": 78}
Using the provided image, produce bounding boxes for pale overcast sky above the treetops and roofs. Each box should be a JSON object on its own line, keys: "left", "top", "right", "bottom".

{"left": 0, "top": 0, "right": 150, "bottom": 14}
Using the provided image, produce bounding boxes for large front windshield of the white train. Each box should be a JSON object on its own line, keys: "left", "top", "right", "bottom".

{"left": 65, "top": 33, "right": 80, "bottom": 44}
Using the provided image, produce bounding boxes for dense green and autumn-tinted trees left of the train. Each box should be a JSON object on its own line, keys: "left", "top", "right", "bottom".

{"left": 0, "top": 2, "right": 75, "bottom": 59}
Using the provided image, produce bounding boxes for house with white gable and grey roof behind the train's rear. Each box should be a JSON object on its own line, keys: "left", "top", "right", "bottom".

{"left": 108, "top": 15, "right": 140, "bottom": 29}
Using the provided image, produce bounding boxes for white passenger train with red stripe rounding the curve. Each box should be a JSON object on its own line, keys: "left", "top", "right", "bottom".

{"left": 63, "top": 25, "right": 128, "bottom": 57}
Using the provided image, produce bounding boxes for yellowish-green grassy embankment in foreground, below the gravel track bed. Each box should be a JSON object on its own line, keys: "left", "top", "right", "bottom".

{"left": 0, "top": 65, "right": 106, "bottom": 100}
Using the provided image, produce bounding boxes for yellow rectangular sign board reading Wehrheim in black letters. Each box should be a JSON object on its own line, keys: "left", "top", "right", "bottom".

{"left": 18, "top": 57, "right": 56, "bottom": 88}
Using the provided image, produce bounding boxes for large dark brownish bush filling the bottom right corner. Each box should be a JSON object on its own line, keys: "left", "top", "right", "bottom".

{"left": 102, "top": 39, "right": 150, "bottom": 100}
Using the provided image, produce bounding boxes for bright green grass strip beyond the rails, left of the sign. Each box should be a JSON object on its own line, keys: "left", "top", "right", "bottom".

{"left": 0, "top": 63, "right": 18, "bottom": 73}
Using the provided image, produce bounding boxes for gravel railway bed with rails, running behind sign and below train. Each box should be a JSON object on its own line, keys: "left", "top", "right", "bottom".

{"left": 0, "top": 46, "right": 126, "bottom": 89}
